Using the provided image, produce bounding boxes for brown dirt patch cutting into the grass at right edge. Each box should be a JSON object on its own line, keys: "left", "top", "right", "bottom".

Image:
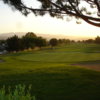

{"left": 73, "top": 63, "right": 100, "bottom": 71}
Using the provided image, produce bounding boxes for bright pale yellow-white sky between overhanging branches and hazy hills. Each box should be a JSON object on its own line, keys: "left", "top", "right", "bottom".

{"left": 0, "top": 0, "right": 100, "bottom": 38}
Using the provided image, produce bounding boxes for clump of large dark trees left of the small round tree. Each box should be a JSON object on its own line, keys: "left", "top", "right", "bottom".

{"left": 6, "top": 32, "right": 47, "bottom": 51}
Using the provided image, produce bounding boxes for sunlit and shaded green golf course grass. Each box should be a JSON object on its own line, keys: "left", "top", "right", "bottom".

{"left": 0, "top": 44, "right": 100, "bottom": 100}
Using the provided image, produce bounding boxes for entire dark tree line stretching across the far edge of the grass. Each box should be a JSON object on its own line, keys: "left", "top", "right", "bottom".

{"left": 0, "top": 32, "right": 100, "bottom": 52}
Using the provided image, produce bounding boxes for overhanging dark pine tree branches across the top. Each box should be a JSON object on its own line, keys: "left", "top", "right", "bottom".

{"left": 2, "top": 0, "right": 100, "bottom": 27}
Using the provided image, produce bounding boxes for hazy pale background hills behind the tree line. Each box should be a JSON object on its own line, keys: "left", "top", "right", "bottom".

{"left": 0, "top": 32, "right": 93, "bottom": 41}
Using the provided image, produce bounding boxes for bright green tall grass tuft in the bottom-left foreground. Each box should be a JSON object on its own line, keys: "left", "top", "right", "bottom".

{"left": 0, "top": 85, "right": 35, "bottom": 100}
